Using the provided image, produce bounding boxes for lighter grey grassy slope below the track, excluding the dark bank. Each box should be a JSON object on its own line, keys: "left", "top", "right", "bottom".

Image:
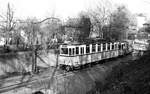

{"left": 2, "top": 55, "right": 132, "bottom": 94}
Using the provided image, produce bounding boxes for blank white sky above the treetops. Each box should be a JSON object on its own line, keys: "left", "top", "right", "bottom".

{"left": 0, "top": 0, "right": 150, "bottom": 19}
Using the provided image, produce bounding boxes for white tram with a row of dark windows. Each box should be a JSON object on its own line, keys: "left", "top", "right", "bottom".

{"left": 59, "top": 42, "right": 128, "bottom": 70}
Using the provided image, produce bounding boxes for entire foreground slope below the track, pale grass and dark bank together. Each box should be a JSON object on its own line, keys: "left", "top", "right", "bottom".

{"left": 2, "top": 52, "right": 150, "bottom": 94}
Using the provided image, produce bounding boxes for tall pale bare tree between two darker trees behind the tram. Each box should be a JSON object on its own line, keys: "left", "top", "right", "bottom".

{"left": 88, "top": 0, "right": 112, "bottom": 37}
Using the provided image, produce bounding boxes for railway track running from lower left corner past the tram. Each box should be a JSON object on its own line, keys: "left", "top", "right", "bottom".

{"left": 0, "top": 55, "right": 132, "bottom": 93}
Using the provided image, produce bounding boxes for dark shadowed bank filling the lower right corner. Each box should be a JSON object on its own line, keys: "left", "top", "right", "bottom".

{"left": 87, "top": 51, "right": 150, "bottom": 94}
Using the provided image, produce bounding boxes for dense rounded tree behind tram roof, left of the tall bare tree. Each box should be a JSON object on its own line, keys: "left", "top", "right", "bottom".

{"left": 64, "top": 12, "right": 91, "bottom": 42}
